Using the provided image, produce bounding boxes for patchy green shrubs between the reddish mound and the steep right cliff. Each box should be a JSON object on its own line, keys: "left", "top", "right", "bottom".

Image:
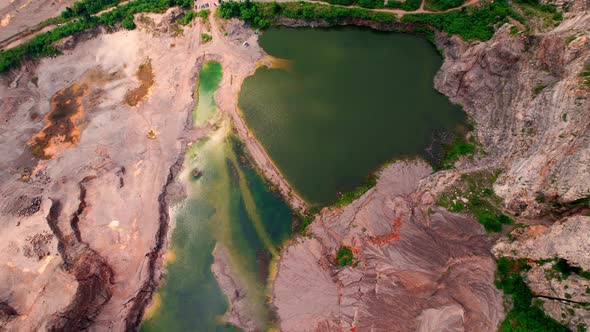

{"left": 437, "top": 171, "right": 514, "bottom": 232}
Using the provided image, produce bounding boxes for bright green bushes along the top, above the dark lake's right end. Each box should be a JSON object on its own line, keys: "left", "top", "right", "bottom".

{"left": 401, "top": 0, "right": 520, "bottom": 41}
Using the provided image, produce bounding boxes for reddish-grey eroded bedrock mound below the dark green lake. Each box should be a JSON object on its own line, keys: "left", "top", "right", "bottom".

{"left": 273, "top": 161, "right": 504, "bottom": 331}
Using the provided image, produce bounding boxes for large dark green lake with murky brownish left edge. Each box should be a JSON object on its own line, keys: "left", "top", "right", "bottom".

{"left": 239, "top": 27, "right": 464, "bottom": 205}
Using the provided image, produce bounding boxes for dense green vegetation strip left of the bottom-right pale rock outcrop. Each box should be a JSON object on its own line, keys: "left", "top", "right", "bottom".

{"left": 496, "top": 257, "right": 569, "bottom": 332}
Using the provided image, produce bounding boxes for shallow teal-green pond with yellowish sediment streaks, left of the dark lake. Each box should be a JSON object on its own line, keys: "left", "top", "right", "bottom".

{"left": 142, "top": 63, "right": 292, "bottom": 331}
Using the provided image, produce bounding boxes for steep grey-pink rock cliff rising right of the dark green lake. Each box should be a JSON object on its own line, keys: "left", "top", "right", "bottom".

{"left": 435, "top": 9, "right": 590, "bottom": 216}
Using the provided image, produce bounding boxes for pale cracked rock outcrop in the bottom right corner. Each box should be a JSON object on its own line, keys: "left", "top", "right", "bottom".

{"left": 493, "top": 216, "right": 590, "bottom": 331}
